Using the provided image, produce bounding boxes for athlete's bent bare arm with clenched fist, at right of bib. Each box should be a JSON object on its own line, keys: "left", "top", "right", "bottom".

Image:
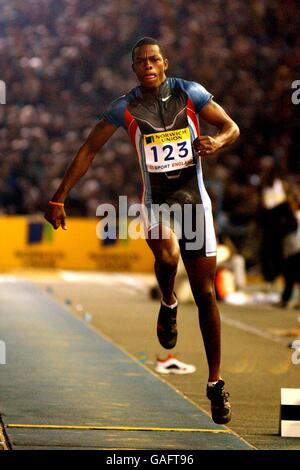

{"left": 194, "top": 100, "right": 240, "bottom": 155}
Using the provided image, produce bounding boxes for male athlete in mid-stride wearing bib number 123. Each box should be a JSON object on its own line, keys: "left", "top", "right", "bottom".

{"left": 45, "top": 38, "right": 239, "bottom": 424}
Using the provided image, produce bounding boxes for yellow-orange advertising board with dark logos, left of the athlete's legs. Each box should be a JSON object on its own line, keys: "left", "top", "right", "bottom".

{"left": 0, "top": 216, "right": 153, "bottom": 272}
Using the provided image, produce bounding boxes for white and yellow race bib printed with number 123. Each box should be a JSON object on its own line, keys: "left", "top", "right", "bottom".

{"left": 144, "top": 127, "right": 194, "bottom": 173}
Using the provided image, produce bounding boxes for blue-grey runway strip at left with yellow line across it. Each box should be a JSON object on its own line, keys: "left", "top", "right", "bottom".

{"left": 0, "top": 281, "right": 251, "bottom": 450}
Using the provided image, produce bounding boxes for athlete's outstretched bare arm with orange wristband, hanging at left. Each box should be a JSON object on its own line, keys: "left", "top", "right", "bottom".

{"left": 44, "top": 119, "right": 117, "bottom": 230}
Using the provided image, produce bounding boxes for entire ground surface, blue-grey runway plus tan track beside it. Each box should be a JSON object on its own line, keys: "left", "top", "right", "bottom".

{"left": 0, "top": 272, "right": 300, "bottom": 450}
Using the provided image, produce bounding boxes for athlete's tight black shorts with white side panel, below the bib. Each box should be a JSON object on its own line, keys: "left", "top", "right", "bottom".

{"left": 144, "top": 166, "right": 217, "bottom": 258}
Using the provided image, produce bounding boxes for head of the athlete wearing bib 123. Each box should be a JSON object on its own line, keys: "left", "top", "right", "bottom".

{"left": 132, "top": 44, "right": 168, "bottom": 89}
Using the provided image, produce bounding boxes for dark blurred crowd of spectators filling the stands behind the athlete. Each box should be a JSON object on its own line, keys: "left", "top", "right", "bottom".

{"left": 0, "top": 0, "right": 300, "bottom": 265}
